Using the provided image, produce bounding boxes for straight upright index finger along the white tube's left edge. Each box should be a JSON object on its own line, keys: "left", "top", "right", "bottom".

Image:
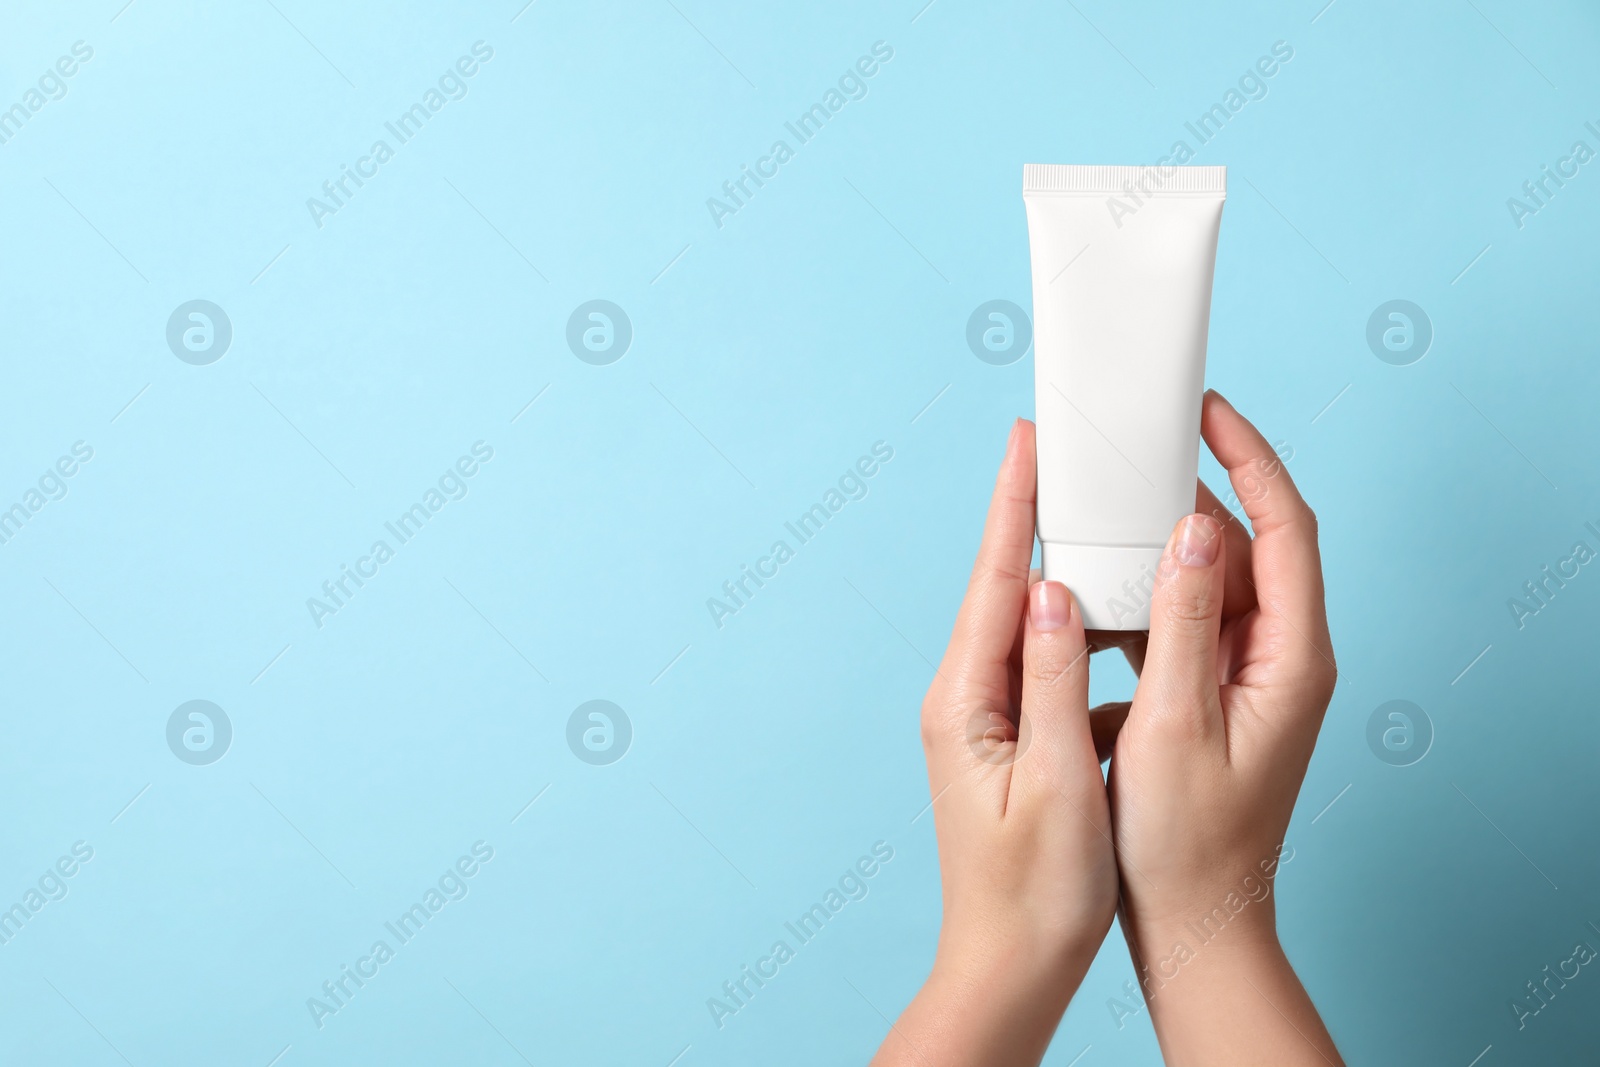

{"left": 941, "top": 419, "right": 1035, "bottom": 691}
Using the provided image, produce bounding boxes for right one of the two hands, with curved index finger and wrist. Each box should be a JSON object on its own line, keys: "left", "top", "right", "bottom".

{"left": 1107, "top": 394, "right": 1339, "bottom": 1065}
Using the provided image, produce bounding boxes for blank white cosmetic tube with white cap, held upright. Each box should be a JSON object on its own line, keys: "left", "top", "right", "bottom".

{"left": 1022, "top": 163, "right": 1227, "bottom": 630}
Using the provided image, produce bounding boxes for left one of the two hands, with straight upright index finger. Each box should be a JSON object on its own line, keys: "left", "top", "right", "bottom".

{"left": 874, "top": 419, "right": 1117, "bottom": 1067}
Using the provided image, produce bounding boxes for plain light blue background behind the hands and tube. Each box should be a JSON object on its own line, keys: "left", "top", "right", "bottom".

{"left": 0, "top": 0, "right": 1600, "bottom": 1067}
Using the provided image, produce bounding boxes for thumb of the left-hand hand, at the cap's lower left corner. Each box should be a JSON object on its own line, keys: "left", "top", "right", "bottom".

{"left": 1011, "top": 582, "right": 1099, "bottom": 798}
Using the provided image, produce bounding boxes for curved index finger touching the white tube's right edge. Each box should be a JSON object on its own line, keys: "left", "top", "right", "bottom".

{"left": 1200, "top": 392, "right": 1333, "bottom": 667}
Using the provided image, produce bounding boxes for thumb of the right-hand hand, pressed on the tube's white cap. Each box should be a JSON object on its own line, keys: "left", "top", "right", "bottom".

{"left": 1136, "top": 515, "right": 1227, "bottom": 748}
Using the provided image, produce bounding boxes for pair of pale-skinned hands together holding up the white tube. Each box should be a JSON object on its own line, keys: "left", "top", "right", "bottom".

{"left": 872, "top": 394, "right": 1344, "bottom": 1067}
